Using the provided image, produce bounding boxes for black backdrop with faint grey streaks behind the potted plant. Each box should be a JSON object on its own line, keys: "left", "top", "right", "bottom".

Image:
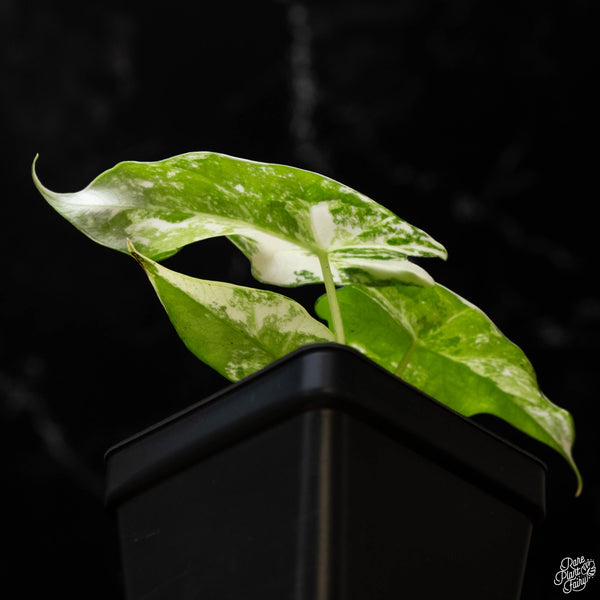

{"left": 0, "top": 0, "right": 600, "bottom": 600}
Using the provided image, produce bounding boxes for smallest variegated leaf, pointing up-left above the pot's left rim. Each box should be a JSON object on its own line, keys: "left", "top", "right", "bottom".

{"left": 130, "top": 245, "right": 333, "bottom": 381}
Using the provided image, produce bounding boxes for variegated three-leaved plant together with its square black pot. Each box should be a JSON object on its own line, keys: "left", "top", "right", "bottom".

{"left": 33, "top": 152, "right": 581, "bottom": 600}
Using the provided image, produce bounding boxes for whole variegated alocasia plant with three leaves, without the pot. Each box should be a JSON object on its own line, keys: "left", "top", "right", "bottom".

{"left": 33, "top": 152, "right": 581, "bottom": 493}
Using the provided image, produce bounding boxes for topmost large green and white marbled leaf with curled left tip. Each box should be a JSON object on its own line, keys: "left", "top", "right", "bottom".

{"left": 33, "top": 152, "right": 446, "bottom": 286}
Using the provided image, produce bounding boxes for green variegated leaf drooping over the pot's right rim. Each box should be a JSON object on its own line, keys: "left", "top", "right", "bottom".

{"left": 316, "top": 284, "right": 582, "bottom": 494}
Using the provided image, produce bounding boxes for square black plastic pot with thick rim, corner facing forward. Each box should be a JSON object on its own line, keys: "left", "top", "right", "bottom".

{"left": 107, "top": 344, "right": 545, "bottom": 600}
